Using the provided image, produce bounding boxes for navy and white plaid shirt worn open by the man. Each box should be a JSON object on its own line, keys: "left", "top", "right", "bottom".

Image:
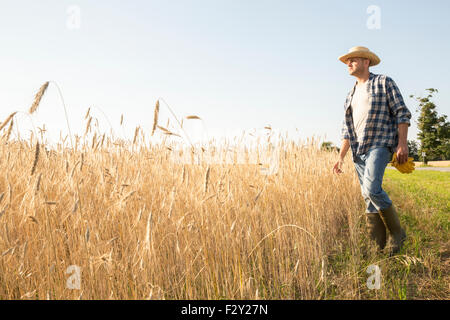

{"left": 341, "top": 72, "right": 411, "bottom": 161}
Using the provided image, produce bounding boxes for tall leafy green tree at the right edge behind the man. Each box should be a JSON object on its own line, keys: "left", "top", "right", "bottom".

{"left": 410, "top": 88, "right": 450, "bottom": 164}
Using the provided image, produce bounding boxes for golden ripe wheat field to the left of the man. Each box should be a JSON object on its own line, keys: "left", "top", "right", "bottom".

{"left": 0, "top": 87, "right": 370, "bottom": 299}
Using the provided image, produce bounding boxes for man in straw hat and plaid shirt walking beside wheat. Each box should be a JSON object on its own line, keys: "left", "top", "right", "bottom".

{"left": 333, "top": 47, "right": 411, "bottom": 254}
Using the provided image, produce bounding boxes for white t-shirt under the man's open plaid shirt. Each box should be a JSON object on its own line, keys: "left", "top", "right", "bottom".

{"left": 351, "top": 83, "right": 370, "bottom": 142}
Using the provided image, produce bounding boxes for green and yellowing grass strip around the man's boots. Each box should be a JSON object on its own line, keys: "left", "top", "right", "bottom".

{"left": 324, "top": 170, "right": 450, "bottom": 300}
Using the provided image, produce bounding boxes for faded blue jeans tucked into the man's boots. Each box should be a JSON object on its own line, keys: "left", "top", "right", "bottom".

{"left": 355, "top": 147, "right": 392, "bottom": 213}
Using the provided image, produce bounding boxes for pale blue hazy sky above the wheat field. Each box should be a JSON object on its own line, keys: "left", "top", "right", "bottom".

{"left": 0, "top": 0, "right": 450, "bottom": 144}
